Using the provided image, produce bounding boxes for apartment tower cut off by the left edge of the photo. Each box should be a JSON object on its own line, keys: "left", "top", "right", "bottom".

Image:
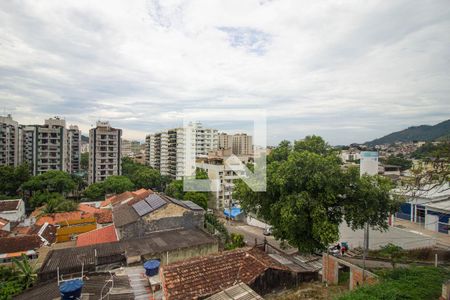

{"left": 0, "top": 115, "right": 22, "bottom": 167}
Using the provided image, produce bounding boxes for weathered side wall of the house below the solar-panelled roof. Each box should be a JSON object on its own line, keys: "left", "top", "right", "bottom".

{"left": 117, "top": 203, "right": 204, "bottom": 240}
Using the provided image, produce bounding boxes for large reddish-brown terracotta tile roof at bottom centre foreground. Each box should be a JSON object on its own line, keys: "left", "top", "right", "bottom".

{"left": 161, "top": 248, "right": 289, "bottom": 300}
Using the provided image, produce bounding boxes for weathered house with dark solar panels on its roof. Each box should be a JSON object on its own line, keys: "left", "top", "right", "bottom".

{"left": 113, "top": 193, "right": 205, "bottom": 240}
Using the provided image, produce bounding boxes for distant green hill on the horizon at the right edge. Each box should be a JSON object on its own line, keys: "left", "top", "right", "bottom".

{"left": 365, "top": 119, "right": 450, "bottom": 146}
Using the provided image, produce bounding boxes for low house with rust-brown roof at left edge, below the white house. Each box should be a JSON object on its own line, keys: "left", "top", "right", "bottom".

{"left": 0, "top": 235, "right": 42, "bottom": 263}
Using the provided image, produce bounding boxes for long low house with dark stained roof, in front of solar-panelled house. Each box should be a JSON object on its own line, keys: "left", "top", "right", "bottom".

{"left": 39, "top": 229, "right": 219, "bottom": 281}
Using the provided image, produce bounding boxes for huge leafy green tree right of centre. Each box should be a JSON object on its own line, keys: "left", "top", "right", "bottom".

{"left": 234, "top": 136, "right": 398, "bottom": 252}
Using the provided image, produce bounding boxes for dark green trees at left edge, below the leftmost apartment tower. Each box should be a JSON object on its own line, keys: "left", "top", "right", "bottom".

{"left": 0, "top": 164, "right": 30, "bottom": 199}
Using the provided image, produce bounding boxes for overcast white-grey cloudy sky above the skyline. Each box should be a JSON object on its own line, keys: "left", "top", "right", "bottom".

{"left": 0, "top": 0, "right": 450, "bottom": 144}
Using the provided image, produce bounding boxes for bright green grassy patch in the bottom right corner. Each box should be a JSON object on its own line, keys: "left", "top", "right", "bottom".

{"left": 339, "top": 267, "right": 450, "bottom": 300}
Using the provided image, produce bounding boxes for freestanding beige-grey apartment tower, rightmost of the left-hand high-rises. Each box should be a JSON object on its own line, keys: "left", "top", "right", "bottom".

{"left": 88, "top": 121, "right": 122, "bottom": 184}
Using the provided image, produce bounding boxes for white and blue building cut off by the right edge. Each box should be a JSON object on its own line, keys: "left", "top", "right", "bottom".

{"left": 395, "top": 183, "right": 450, "bottom": 234}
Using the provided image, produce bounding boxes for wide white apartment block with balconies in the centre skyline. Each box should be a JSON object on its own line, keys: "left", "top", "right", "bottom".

{"left": 145, "top": 123, "right": 219, "bottom": 179}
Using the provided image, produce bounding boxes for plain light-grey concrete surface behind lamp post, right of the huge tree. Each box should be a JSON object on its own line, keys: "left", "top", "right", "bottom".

{"left": 339, "top": 224, "right": 436, "bottom": 250}
